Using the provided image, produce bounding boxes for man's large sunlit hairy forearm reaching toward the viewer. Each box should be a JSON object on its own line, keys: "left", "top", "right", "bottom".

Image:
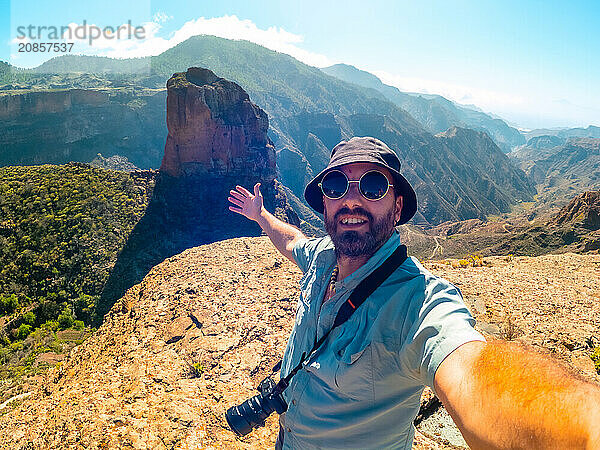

{"left": 434, "top": 341, "right": 600, "bottom": 449}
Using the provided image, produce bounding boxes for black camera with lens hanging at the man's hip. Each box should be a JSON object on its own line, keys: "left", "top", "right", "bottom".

{"left": 225, "top": 377, "right": 287, "bottom": 436}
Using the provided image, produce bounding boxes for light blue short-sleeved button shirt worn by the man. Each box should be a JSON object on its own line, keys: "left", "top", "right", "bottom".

{"left": 281, "top": 233, "right": 484, "bottom": 449}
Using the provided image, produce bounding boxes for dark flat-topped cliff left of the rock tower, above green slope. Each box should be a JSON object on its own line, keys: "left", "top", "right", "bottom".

{"left": 0, "top": 88, "right": 166, "bottom": 167}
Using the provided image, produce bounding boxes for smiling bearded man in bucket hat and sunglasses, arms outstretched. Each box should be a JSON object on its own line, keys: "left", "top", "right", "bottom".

{"left": 229, "top": 137, "right": 600, "bottom": 449}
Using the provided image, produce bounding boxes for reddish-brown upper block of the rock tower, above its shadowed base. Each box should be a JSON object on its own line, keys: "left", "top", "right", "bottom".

{"left": 161, "top": 67, "right": 276, "bottom": 181}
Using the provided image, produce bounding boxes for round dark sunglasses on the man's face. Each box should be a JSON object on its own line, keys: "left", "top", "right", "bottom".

{"left": 319, "top": 170, "right": 394, "bottom": 201}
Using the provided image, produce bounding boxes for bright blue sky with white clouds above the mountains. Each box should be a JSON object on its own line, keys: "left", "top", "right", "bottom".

{"left": 0, "top": 0, "right": 600, "bottom": 128}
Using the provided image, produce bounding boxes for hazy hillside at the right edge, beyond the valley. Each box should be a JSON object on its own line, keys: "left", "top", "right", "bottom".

{"left": 509, "top": 137, "right": 600, "bottom": 207}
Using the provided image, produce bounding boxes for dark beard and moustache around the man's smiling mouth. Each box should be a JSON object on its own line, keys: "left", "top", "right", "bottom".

{"left": 325, "top": 207, "right": 394, "bottom": 258}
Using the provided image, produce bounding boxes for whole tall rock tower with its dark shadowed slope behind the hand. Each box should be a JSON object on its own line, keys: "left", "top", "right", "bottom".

{"left": 99, "top": 67, "right": 300, "bottom": 314}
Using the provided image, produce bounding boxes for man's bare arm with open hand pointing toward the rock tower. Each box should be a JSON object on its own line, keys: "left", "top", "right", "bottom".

{"left": 228, "top": 183, "right": 305, "bottom": 263}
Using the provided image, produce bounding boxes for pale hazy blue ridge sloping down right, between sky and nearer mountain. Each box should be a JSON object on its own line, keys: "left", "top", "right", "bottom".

{"left": 321, "top": 64, "right": 525, "bottom": 153}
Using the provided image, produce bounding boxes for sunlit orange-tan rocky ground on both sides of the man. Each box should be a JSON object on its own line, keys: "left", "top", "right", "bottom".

{"left": 0, "top": 237, "right": 600, "bottom": 449}
